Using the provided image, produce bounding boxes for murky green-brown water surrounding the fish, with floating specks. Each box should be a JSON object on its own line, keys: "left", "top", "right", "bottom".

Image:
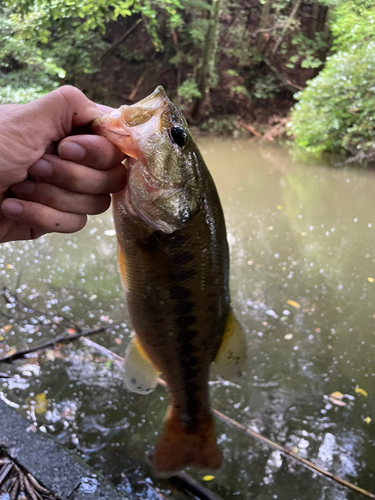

{"left": 0, "top": 139, "right": 375, "bottom": 500}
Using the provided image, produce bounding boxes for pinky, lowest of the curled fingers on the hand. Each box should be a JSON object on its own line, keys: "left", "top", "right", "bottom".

{"left": 1, "top": 198, "right": 87, "bottom": 233}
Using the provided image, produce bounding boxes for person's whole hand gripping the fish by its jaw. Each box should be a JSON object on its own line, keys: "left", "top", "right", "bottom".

{"left": 0, "top": 86, "right": 126, "bottom": 242}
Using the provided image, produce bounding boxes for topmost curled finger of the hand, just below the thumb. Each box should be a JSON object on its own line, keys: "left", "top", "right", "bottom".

{"left": 57, "top": 135, "right": 125, "bottom": 170}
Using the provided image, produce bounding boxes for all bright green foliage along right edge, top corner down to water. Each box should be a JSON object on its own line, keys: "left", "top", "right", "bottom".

{"left": 291, "top": 0, "right": 375, "bottom": 159}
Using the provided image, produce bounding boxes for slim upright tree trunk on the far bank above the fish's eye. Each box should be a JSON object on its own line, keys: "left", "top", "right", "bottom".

{"left": 191, "top": 0, "right": 222, "bottom": 118}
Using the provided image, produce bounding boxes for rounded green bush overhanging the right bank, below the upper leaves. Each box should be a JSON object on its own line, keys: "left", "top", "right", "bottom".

{"left": 291, "top": 42, "right": 375, "bottom": 155}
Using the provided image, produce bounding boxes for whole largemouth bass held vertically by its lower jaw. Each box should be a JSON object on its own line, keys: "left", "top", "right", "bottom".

{"left": 92, "top": 86, "right": 246, "bottom": 477}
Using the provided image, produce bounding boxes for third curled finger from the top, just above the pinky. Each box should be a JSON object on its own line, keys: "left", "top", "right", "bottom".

{"left": 12, "top": 180, "right": 111, "bottom": 215}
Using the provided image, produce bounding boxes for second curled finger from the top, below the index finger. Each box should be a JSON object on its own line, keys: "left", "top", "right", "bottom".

{"left": 29, "top": 155, "right": 126, "bottom": 194}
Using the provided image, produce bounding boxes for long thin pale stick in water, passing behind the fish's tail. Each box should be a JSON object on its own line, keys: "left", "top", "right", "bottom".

{"left": 82, "top": 339, "right": 375, "bottom": 500}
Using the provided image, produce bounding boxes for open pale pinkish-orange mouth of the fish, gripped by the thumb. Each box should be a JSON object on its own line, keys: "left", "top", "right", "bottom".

{"left": 91, "top": 86, "right": 169, "bottom": 160}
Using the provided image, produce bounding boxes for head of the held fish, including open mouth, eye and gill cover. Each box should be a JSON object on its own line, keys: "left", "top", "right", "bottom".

{"left": 92, "top": 86, "right": 203, "bottom": 233}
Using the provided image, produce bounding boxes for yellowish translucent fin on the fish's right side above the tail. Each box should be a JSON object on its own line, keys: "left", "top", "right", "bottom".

{"left": 211, "top": 309, "right": 247, "bottom": 379}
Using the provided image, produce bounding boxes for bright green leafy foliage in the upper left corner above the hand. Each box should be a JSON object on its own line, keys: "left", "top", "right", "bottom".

{"left": 0, "top": 0, "right": 181, "bottom": 102}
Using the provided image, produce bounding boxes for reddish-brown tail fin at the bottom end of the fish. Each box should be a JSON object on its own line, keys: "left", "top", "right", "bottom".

{"left": 151, "top": 407, "right": 222, "bottom": 477}
